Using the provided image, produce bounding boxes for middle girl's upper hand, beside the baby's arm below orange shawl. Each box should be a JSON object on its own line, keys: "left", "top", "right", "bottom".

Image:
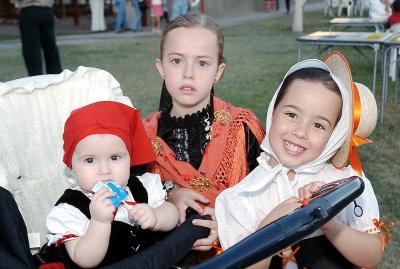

{"left": 170, "top": 188, "right": 209, "bottom": 223}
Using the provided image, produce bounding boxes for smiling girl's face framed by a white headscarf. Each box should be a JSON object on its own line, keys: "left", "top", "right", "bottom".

{"left": 269, "top": 79, "right": 342, "bottom": 168}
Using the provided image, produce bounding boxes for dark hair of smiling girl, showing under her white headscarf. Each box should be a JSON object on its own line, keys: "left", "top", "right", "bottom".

{"left": 274, "top": 67, "right": 342, "bottom": 109}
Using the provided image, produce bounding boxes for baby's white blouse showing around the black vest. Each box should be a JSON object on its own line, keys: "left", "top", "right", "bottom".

{"left": 46, "top": 173, "right": 166, "bottom": 245}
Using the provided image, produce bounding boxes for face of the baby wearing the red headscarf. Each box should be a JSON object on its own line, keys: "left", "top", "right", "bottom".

{"left": 72, "top": 134, "right": 130, "bottom": 191}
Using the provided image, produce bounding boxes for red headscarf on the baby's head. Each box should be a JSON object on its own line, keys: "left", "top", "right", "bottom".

{"left": 63, "top": 101, "right": 156, "bottom": 168}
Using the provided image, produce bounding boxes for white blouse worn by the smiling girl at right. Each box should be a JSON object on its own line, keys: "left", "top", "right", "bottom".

{"left": 215, "top": 152, "right": 379, "bottom": 249}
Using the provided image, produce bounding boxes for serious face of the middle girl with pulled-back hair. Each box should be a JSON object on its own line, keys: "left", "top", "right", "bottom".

{"left": 156, "top": 27, "right": 225, "bottom": 116}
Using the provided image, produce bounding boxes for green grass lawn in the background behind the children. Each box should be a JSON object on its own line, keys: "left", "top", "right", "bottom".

{"left": 0, "top": 9, "right": 400, "bottom": 269}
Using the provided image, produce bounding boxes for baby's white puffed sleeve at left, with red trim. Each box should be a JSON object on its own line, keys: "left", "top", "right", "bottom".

{"left": 46, "top": 203, "right": 89, "bottom": 245}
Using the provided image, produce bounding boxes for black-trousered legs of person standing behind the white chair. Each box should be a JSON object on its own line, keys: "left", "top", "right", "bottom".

{"left": 15, "top": 0, "right": 62, "bottom": 76}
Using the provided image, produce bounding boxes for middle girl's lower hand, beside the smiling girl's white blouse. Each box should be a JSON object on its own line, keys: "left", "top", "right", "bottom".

{"left": 192, "top": 207, "right": 218, "bottom": 251}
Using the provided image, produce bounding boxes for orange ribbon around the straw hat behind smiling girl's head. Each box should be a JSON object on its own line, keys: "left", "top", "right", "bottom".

{"left": 349, "top": 83, "right": 372, "bottom": 176}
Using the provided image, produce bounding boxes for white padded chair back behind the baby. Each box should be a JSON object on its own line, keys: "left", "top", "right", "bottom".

{"left": 0, "top": 67, "right": 132, "bottom": 247}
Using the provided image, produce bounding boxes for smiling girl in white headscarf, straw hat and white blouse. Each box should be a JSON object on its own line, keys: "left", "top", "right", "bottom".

{"left": 215, "top": 52, "right": 384, "bottom": 269}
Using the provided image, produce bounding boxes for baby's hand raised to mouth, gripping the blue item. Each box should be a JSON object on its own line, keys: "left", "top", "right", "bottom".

{"left": 89, "top": 189, "right": 115, "bottom": 223}
